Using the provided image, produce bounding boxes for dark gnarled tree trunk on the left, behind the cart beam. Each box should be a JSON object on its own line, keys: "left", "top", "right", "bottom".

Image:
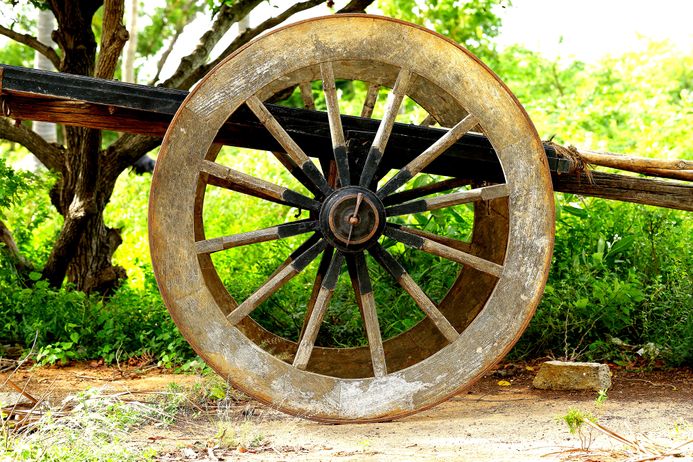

{"left": 43, "top": 0, "right": 127, "bottom": 293}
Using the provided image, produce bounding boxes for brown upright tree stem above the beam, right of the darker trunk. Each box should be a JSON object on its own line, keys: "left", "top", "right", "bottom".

{"left": 95, "top": 0, "right": 130, "bottom": 79}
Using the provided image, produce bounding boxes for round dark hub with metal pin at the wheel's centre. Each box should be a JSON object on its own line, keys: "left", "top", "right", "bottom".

{"left": 320, "top": 186, "right": 385, "bottom": 252}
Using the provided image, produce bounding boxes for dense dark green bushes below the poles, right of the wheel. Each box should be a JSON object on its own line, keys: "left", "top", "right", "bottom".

{"left": 514, "top": 195, "right": 693, "bottom": 364}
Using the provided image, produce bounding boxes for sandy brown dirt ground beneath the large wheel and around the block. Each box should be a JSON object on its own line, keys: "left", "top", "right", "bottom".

{"left": 0, "top": 364, "right": 693, "bottom": 461}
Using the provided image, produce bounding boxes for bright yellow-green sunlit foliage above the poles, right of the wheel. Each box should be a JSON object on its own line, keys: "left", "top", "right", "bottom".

{"left": 489, "top": 42, "right": 693, "bottom": 159}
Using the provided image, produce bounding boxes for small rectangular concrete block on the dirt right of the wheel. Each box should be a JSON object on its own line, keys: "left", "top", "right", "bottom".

{"left": 532, "top": 361, "right": 611, "bottom": 391}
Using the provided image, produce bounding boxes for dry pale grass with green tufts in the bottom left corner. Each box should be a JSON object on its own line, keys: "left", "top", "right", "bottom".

{"left": 0, "top": 362, "right": 268, "bottom": 462}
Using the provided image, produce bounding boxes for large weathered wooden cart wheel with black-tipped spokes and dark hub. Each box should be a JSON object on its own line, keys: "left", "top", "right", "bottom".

{"left": 150, "top": 15, "right": 554, "bottom": 422}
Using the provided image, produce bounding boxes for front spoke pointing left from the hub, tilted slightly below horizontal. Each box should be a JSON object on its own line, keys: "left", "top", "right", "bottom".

{"left": 195, "top": 220, "right": 320, "bottom": 254}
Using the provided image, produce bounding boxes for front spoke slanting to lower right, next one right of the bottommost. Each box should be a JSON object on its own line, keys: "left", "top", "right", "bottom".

{"left": 368, "top": 244, "right": 460, "bottom": 343}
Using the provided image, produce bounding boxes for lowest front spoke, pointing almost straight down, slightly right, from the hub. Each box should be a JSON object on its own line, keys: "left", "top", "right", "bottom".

{"left": 354, "top": 253, "right": 387, "bottom": 377}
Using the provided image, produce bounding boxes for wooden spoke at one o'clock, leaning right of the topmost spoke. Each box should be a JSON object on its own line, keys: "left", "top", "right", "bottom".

{"left": 359, "top": 69, "right": 412, "bottom": 188}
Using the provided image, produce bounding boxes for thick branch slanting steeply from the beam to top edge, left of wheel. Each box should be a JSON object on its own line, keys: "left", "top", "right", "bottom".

{"left": 162, "top": 0, "right": 263, "bottom": 88}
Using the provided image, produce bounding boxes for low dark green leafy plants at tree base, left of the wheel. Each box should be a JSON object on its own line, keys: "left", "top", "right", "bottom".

{"left": 0, "top": 266, "right": 194, "bottom": 367}
